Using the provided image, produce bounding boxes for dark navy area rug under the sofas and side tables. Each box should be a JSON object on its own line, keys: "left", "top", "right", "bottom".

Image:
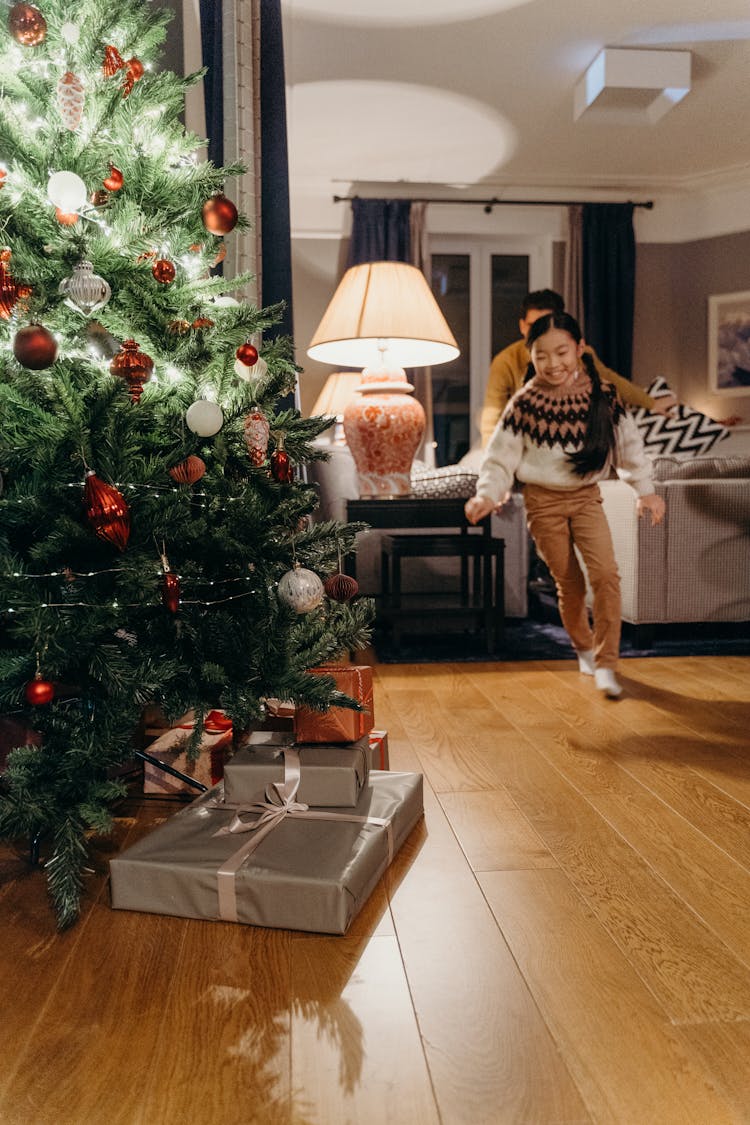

{"left": 374, "top": 606, "right": 750, "bottom": 664}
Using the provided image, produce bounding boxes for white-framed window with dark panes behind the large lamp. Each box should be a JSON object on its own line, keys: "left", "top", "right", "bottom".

{"left": 431, "top": 236, "right": 552, "bottom": 465}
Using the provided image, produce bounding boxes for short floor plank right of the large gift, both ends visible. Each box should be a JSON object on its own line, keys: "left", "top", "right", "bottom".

{"left": 440, "top": 789, "right": 557, "bottom": 871}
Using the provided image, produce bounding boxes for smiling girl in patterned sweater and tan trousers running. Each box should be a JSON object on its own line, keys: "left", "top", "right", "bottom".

{"left": 466, "top": 313, "right": 665, "bottom": 699}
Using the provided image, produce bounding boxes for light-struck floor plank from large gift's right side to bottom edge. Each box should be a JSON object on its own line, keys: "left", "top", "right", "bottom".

{"left": 389, "top": 788, "right": 589, "bottom": 1125}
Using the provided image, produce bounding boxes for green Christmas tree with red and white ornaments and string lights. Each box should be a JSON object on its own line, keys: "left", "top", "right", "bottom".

{"left": 0, "top": 0, "right": 371, "bottom": 926}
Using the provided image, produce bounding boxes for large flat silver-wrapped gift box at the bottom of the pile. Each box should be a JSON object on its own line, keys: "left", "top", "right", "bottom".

{"left": 110, "top": 773, "right": 423, "bottom": 934}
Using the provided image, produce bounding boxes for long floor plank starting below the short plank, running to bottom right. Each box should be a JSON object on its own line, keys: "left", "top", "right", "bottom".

{"left": 479, "top": 870, "right": 737, "bottom": 1125}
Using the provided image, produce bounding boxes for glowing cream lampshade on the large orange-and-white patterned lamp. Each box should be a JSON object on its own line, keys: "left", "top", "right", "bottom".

{"left": 307, "top": 262, "right": 459, "bottom": 367}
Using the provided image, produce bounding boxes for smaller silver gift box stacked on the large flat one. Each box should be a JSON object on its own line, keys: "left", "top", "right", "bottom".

{"left": 224, "top": 730, "right": 370, "bottom": 808}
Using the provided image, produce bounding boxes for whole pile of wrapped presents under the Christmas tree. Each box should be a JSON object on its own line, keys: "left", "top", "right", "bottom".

{"left": 110, "top": 665, "right": 423, "bottom": 934}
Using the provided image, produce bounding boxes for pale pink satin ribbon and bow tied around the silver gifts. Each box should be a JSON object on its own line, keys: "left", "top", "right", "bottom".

{"left": 205, "top": 747, "right": 394, "bottom": 921}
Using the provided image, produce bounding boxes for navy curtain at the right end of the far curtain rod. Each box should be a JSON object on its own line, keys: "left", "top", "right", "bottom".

{"left": 582, "top": 204, "right": 635, "bottom": 379}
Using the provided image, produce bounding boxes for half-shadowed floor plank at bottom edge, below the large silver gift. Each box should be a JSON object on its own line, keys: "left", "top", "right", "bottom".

{"left": 291, "top": 936, "right": 440, "bottom": 1125}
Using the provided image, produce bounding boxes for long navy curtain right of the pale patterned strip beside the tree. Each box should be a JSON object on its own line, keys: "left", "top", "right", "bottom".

{"left": 261, "top": 0, "right": 293, "bottom": 336}
